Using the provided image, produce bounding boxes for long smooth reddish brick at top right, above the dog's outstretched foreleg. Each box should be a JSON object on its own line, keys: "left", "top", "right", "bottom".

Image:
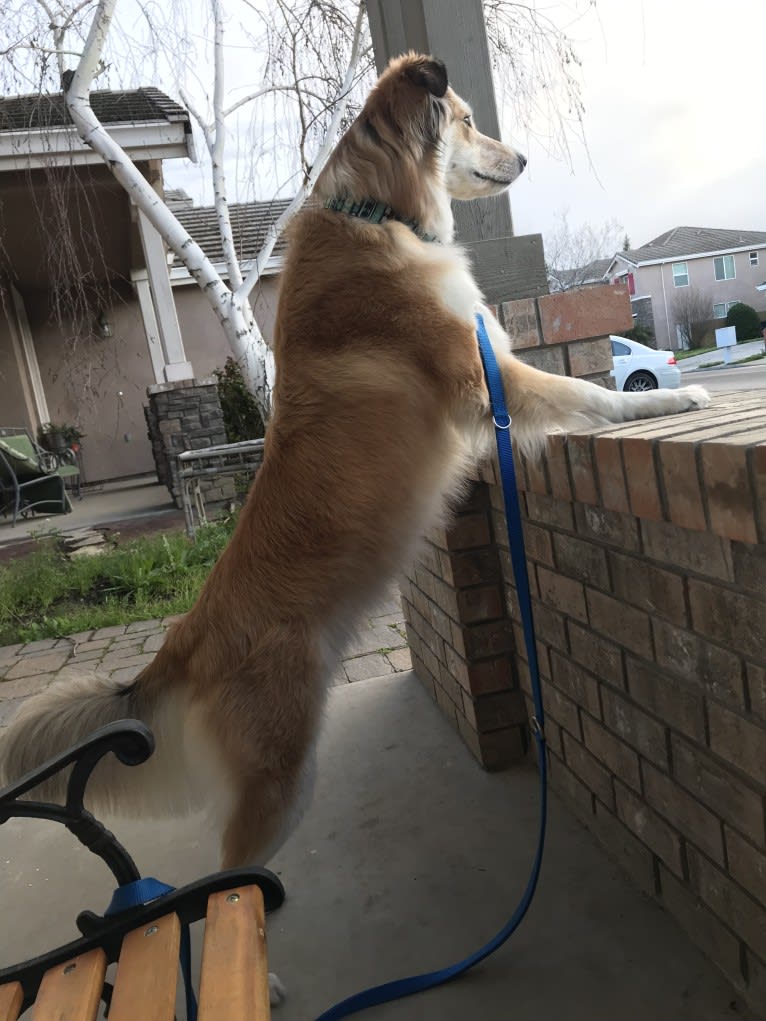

{"left": 537, "top": 284, "right": 633, "bottom": 344}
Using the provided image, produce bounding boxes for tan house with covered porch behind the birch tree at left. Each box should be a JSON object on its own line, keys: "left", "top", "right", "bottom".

{"left": 0, "top": 88, "right": 287, "bottom": 482}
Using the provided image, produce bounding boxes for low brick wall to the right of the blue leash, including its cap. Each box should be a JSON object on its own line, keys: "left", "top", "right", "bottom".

{"left": 510, "top": 392, "right": 766, "bottom": 1011}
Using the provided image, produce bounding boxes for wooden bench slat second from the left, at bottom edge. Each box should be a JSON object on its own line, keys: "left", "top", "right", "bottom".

{"left": 32, "top": 949, "right": 106, "bottom": 1021}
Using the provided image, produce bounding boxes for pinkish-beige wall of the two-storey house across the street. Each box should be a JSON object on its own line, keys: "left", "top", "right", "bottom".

{"left": 620, "top": 247, "right": 766, "bottom": 349}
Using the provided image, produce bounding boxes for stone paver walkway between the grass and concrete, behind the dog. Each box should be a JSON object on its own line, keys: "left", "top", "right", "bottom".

{"left": 0, "top": 589, "right": 412, "bottom": 727}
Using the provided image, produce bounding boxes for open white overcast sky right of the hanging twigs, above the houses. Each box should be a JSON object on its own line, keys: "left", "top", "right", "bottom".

{"left": 504, "top": 0, "right": 766, "bottom": 247}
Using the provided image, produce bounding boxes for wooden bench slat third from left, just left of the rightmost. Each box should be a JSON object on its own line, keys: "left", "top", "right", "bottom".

{"left": 109, "top": 915, "right": 181, "bottom": 1021}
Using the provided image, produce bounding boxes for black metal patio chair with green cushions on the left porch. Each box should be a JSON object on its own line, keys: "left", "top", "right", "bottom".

{"left": 0, "top": 427, "right": 80, "bottom": 525}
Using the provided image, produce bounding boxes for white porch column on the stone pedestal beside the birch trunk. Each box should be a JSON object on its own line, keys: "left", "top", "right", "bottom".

{"left": 136, "top": 209, "right": 194, "bottom": 383}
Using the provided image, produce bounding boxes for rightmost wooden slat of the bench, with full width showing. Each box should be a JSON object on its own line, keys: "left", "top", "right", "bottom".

{"left": 198, "top": 886, "right": 272, "bottom": 1021}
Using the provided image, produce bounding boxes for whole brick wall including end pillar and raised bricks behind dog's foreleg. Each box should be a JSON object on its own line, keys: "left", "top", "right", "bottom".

{"left": 402, "top": 279, "right": 766, "bottom": 1012}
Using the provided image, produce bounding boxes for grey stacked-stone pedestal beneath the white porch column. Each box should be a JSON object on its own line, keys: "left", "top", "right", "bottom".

{"left": 144, "top": 379, "right": 235, "bottom": 507}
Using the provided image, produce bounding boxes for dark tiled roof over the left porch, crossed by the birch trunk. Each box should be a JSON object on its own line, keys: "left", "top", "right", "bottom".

{"left": 0, "top": 86, "right": 189, "bottom": 132}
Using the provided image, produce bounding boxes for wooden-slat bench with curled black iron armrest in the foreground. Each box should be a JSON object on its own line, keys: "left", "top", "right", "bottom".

{"left": 0, "top": 720, "right": 285, "bottom": 1021}
